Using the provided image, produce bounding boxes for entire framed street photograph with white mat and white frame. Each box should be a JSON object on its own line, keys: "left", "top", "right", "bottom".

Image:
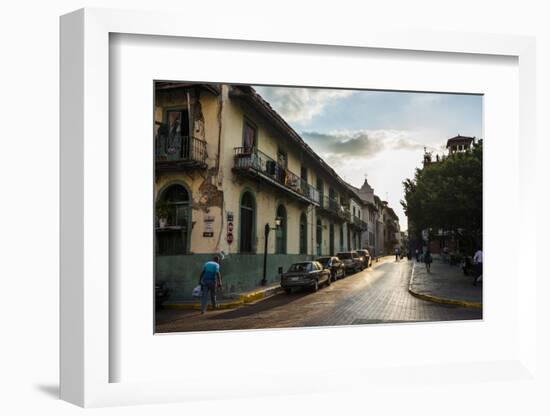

{"left": 61, "top": 9, "right": 536, "bottom": 406}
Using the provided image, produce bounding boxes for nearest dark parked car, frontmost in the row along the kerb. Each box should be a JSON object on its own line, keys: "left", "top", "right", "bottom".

{"left": 281, "top": 261, "right": 332, "bottom": 293}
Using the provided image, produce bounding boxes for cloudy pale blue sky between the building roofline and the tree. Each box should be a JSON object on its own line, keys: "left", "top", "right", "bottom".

{"left": 254, "top": 86, "right": 483, "bottom": 230}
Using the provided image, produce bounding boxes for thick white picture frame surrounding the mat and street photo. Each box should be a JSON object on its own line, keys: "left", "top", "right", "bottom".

{"left": 60, "top": 9, "right": 537, "bottom": 407}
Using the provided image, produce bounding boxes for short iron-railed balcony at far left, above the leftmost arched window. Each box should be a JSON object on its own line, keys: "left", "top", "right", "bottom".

{"left": 155, "top": 135, "right": 207, "bottom": 171}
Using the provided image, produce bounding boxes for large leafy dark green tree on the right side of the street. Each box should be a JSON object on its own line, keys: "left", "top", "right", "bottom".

{"left": 401, "top": 140, "right": 483, "bottom": 254}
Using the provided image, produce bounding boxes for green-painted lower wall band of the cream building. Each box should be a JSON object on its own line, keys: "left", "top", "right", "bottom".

{"left": 155, "top": 254, "right": 312, "bottom": 300}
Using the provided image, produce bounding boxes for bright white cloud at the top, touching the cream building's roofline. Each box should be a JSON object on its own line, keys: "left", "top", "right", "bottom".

{"left": 255, "top": 87, "right": 355, "bottom": 123}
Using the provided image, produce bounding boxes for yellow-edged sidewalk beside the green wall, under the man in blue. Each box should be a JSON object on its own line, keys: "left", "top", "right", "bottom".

{"left": 162, "top": 283, "right": 282, "bottom": 310}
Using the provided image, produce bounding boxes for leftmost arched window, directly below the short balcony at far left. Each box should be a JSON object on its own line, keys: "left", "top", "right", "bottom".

{"left": 156, "top": 184, "right": 191, "bottom": 255}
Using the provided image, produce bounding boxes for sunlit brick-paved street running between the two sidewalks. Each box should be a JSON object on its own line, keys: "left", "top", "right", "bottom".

{"left": 156, "top": 257, "right": 482, "bottom": 332}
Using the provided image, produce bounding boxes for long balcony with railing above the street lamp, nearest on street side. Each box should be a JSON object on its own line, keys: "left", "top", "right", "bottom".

{"left": 233, "top": 147, "right": 320, "bottom": 206}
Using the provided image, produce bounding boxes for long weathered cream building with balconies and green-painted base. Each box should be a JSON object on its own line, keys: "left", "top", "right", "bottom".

{"left": 154, "top": 82, "right": 376, "bottom": 298}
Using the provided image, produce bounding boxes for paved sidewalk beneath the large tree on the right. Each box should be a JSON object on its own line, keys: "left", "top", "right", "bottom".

{"left": 409, "top": 259, "right": 483, "bottom": 308}
